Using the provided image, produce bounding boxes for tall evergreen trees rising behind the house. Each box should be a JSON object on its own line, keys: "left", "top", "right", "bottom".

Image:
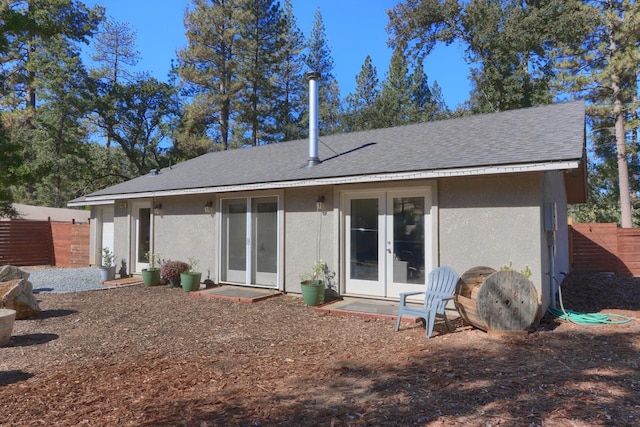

{"left": 0, "top": 0, "right": 640, "bottom": 227}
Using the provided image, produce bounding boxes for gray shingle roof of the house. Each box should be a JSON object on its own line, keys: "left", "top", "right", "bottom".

{"left": 88, "top": 102, "right": 585, "bottom": 198}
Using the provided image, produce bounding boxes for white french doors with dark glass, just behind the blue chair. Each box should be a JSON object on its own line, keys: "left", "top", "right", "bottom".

{"left": 345, "top": 188, "right": 432, "bottom": 298}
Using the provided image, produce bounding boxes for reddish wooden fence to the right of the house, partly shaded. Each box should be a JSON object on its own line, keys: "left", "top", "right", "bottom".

{"left": 569, "top": 223, "right": 640, "bottom": 276}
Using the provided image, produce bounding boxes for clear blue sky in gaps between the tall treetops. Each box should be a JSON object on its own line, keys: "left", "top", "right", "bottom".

{"left": 84, "top": 0, "right": 470, "bottom": 109}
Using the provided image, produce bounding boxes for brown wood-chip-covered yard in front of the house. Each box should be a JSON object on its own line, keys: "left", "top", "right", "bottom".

{"left": 0, "top": 275, "right": 640, "bottom": 427}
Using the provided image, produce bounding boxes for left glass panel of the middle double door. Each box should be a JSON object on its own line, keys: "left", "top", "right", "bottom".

{"left": 221, "top": 199, "right": 247, "bottom": 283}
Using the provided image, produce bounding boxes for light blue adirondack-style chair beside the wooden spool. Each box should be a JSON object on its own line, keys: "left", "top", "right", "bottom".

{"left": 396, "top": 267, "right": 458, "bottom": 338}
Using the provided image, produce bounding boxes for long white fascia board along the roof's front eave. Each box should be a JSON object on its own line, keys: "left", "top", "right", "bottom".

{"left": 84, "top": 160, "right": 580, "bottom": 205}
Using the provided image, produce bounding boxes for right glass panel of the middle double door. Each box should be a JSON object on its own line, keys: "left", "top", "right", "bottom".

{"left": 251, "top": 197, "right": 278, "bottom": 287}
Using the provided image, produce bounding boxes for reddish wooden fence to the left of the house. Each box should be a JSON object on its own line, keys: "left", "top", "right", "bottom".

{"left": 0, "top": 221, "right": 89, "bottom": 267}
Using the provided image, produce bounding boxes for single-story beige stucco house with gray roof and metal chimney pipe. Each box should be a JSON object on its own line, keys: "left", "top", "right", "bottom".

{"left": 69, "top": 88, "right": 586, "bottom": 316}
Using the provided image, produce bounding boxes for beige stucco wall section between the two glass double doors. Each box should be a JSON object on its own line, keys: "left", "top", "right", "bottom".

{"left": 284, "top": 186, "right": 338, "bottom": 293}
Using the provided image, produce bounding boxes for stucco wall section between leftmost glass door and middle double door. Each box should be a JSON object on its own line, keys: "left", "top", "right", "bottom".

{"left": 153, "top": 195, "right": 218, "bottom": 282}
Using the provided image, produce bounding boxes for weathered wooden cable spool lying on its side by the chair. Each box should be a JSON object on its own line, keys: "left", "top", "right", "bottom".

{"left": 455, "top": 267, "right": 539, "bottom": 332}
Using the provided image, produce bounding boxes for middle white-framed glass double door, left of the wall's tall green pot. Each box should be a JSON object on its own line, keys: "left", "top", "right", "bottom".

{"left": 220, "top": 197, "right": 279, "bottom": 288}
